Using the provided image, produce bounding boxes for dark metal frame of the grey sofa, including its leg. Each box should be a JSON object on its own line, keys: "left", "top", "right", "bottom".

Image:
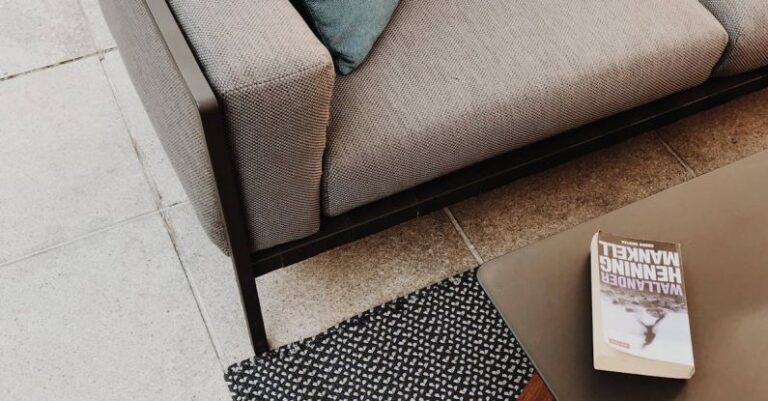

{"left": 146, "top": 0, "right": 768, "bottom": 354}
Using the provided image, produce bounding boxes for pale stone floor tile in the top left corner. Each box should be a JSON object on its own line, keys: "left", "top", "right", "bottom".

{"left": 0, "top": 0, "right": 95, "bottom": 78}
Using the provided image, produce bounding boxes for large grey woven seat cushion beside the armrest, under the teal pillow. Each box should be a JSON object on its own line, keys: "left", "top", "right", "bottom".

{"left": 323, "top": 0, "right": 728, "bottom": 215}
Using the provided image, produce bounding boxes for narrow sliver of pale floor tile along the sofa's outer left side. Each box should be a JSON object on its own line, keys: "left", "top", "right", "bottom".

{"left": 102, "top": 51, "right": 187, "bottom": 207}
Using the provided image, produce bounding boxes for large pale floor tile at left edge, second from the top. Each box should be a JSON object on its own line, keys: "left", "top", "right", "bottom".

{"left": 0, "top": 57, "right": 156, "bottom": 265}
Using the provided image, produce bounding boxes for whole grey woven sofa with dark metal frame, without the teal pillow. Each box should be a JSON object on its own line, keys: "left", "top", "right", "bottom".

{"left": 100, "top": 0, "right": 768, "bottom": 352}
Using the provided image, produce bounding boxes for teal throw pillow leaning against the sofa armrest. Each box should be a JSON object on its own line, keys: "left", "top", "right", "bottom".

{"left": 291, "top": 0, "right": 399, "bottom": 75}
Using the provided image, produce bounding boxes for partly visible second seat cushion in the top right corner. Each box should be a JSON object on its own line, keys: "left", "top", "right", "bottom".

{"left": 701, "top": 0, "right": 768, "bottom": 75}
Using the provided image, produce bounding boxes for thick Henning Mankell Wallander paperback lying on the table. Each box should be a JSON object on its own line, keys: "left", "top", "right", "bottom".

{"left": 591, "top": 231, "right": 694, "bottom": 379}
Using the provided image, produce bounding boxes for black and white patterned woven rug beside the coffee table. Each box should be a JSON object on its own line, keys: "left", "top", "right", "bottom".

{"left": 226, "top": 271, "right": 534, "bottom": 401}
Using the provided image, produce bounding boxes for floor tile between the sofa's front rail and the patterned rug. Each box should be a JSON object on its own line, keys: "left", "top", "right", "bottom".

{"left": 257, "top": 211, "right": 477, "bottom": 346}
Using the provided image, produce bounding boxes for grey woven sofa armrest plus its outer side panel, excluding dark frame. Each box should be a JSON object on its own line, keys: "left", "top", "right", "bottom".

{"left": 102, "top": 0, "right": 335, "bottom": 251}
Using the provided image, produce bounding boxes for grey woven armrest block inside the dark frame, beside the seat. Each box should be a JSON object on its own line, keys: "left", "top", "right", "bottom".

{"left": 168, "top": 0, "right": 335, "bottom": 250}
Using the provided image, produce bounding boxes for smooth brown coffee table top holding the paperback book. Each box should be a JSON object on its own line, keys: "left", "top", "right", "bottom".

{"left": 478, "top": 151, "right": 768, "bottom": 401}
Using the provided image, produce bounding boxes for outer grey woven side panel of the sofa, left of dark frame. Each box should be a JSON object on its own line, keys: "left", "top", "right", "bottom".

{"left": 100, "top": 0, "right": 228, "bottom": 253}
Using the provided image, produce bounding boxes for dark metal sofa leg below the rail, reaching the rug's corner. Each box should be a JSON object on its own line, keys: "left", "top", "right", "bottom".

{"left": 232, "top": 252, "right": 268, "bottom": 355}
